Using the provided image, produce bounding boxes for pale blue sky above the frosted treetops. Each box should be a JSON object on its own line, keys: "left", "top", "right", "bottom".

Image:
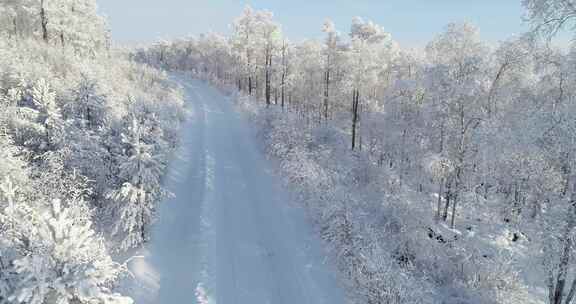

{"left": 98, "top": 0, "right": 568, "bottom": 47}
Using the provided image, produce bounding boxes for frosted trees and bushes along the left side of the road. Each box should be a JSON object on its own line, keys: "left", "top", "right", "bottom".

{"left": 0, "top": 0, "right": 184, "bottom": 304}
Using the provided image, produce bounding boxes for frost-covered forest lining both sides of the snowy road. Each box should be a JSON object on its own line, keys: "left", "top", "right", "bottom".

{"left": 0, "top": 0, "right": 576, "bottom": 304}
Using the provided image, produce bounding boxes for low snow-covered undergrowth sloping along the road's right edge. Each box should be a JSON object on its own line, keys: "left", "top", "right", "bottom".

{"left": 227, "top": 87, "right": 537, "bottom": 303}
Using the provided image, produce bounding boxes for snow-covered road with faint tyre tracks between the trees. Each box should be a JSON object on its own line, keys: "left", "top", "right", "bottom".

{"left": 130, "top": 77, "right": 344, "bottom": 304}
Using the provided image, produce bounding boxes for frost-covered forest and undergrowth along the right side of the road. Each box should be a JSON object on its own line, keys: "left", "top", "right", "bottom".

{"left": 133, "top": 0, "right": 576, "bottom": 304}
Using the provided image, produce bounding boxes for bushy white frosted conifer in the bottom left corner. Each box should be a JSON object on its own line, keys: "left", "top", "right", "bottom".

{"left": 5, "top": 200, "right": 132, "bottom": 304}
